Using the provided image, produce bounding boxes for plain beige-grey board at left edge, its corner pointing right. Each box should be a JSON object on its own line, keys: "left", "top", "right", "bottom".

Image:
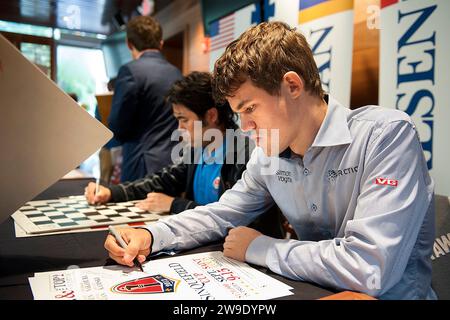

{"left": 0, "top": 35, "right": 112, "bottom": 223}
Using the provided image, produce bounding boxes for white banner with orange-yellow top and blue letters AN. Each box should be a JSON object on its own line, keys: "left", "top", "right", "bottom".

{"left": 298, "top": 0, "right": 353, "bottom": 106}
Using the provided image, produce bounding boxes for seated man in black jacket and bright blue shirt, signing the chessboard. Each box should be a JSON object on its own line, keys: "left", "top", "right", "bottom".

{"left": 86, "top": 72, "right": 254, "bottom": 214}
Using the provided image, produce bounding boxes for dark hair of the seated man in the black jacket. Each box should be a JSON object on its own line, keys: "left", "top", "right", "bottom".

{"left": 166, "top": 71, "right": 237, "bottom": 129}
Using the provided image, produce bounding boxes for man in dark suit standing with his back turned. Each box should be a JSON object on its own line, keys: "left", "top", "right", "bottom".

{"left": 108, "top": 16, "right": 181, "bottom": 182}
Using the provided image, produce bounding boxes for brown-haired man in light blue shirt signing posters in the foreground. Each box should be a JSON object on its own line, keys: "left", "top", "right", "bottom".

{"left": 105, "top": 22, "right": 435, "bottom": 299}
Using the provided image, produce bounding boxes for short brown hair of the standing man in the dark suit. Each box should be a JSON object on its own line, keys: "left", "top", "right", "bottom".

{"left": 127, "top": 16, "right": 162, "bottom": 51}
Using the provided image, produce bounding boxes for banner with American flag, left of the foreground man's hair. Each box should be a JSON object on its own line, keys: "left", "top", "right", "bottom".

{"left": 209, "top": 3, "right": 261, "bottom": 70}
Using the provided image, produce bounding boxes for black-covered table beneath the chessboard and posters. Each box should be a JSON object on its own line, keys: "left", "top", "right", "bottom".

{"left": 0, "top": 178, "right": 335, "bottom": 300}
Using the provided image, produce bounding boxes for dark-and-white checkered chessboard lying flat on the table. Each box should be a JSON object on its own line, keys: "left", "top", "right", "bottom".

{"left": 12, "top": 196, "right": 160, "bottom": 234}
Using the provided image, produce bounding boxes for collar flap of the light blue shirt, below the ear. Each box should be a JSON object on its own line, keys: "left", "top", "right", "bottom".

{"left": 311, "top": 96, "right": 353, "bottom": 147}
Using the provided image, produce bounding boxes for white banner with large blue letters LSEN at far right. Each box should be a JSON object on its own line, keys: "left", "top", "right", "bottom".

{"left": 380, "top": 0, "right": 450, "bottom": 196}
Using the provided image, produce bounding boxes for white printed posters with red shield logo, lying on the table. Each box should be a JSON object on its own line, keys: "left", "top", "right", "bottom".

{"left": 29, "top": 251, "right": 292, "bottom": 300}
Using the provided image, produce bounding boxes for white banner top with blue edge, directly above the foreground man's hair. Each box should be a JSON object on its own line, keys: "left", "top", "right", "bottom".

{"left": 264, "top": 0, "right": 300, "bottom": 27}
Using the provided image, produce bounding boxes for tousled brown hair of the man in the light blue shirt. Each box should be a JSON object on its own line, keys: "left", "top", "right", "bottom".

{"left": 214, "top": 22, "right": 324, "bottom": 101}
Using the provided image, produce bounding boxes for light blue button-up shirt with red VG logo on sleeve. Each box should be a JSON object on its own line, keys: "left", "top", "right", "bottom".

{"left": 148, "top": 97, "right": 435, "bottom": 299}
